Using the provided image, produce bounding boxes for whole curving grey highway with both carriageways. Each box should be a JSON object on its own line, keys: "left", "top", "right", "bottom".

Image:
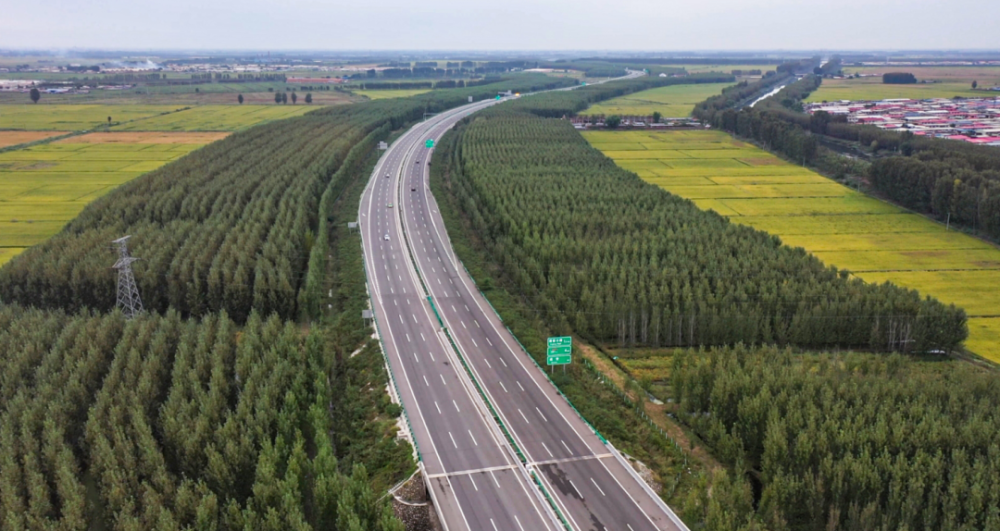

{"left": 359, "top": 74, "right": 687, "bottom": 531}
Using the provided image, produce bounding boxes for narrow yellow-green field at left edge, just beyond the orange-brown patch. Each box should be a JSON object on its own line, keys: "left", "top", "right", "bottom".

{"left": 0, "top": 104, "right": 180, "bottom": 131}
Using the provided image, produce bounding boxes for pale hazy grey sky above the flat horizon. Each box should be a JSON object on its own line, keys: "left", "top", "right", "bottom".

{"left": 0, "top": 0, "right": 1000, "bottom": 50}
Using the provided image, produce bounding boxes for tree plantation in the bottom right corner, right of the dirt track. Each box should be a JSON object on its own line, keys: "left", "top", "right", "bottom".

{"left": 671, "top": 346, "right": 1000, "bottom": 531}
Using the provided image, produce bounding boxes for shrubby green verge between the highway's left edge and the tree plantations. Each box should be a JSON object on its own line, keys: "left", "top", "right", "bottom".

{"left": 309, "top": 127, "right": 416, "bottom": 492}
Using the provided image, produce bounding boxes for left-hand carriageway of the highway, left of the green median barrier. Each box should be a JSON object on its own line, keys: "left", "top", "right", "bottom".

{"left": 358, "top": 102, "right": 558, "bottom": 531}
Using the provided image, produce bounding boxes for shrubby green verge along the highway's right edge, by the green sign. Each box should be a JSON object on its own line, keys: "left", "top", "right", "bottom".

{"left": 430, "top": 128, "right": 699, "bottom": 520}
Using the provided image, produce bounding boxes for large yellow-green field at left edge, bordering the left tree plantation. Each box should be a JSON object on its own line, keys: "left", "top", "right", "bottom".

{"left": 0, "top": 133, "right": 226, "bottom": 265}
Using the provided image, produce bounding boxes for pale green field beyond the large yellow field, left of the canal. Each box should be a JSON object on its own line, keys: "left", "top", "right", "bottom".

{"left": 581, "top": 83, "right": 731, "bottom": 118}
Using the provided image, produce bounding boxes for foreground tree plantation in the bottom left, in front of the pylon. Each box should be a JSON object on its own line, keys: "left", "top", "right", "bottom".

{"left": 0, "top": 306, "right": 402, "bottom": 531}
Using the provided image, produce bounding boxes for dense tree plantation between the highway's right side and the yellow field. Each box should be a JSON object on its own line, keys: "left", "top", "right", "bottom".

{"left": 443, "top": 107, "right": 967, "bottom": 351}
